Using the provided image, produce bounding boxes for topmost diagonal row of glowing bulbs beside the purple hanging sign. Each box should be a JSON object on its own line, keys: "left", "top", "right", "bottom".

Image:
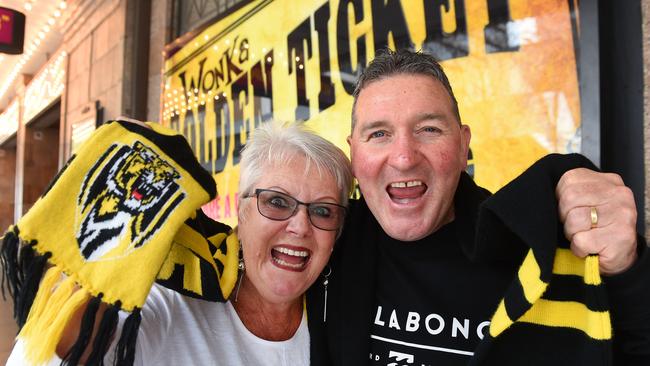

{"left": 0, "top": 0, "right": 67, "bottom": 107}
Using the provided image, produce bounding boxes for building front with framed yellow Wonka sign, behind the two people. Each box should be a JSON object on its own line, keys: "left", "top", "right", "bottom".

{"left": 0, "top": 0, "right": 648, "bottom": 231}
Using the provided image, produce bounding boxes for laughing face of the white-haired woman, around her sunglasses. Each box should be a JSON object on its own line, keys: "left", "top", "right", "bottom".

{"left": 238, "top": 156, "right": 340, "bottom": 303}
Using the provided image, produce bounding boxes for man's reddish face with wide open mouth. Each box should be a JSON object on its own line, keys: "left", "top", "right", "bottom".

{"left": 348, "top": 74, "right": 471, "bottom": 241}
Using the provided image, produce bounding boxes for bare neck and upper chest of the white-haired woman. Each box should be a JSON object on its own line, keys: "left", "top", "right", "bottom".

{"left": 231, "top": 276, "right": 303, "bottom": 341}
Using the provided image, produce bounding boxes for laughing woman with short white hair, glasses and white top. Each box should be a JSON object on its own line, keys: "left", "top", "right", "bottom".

{"left": 8, "top": 119, "right": 352, "bottom": 365}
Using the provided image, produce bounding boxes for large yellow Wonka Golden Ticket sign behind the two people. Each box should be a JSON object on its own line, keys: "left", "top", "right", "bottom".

{"left": 163, "top": 0, "right": 580, "bottom": 224}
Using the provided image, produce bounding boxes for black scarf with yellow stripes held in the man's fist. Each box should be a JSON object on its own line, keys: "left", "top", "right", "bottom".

{"left": 470, "top": 155, "right": 612, "bottom": 365}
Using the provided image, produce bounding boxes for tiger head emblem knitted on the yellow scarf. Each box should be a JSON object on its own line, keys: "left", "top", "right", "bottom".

{"left": 76, "top": 141, "right": 185, "bottom": 261}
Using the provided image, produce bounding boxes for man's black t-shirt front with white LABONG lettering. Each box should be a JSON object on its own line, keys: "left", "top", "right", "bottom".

{"left": 369, "top": 222, "right": 515, "bottom": 366}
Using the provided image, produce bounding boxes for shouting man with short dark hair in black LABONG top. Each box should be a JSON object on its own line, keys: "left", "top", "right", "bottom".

{"left": 308, "top": 51, "right": 650, "bottom": 365}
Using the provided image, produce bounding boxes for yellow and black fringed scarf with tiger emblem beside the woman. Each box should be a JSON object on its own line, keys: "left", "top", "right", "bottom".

{"left": 0, "top": 121, "right": 238, "bottom": 364}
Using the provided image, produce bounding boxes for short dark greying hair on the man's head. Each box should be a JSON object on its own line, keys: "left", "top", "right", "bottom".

{"left": 352, "top": 48, "right": 460, "bottom": 131}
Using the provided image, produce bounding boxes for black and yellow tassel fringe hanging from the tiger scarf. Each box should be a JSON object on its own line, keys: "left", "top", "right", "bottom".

{"left": 0, "top": 226, "right": 142, "bottom": 365}
